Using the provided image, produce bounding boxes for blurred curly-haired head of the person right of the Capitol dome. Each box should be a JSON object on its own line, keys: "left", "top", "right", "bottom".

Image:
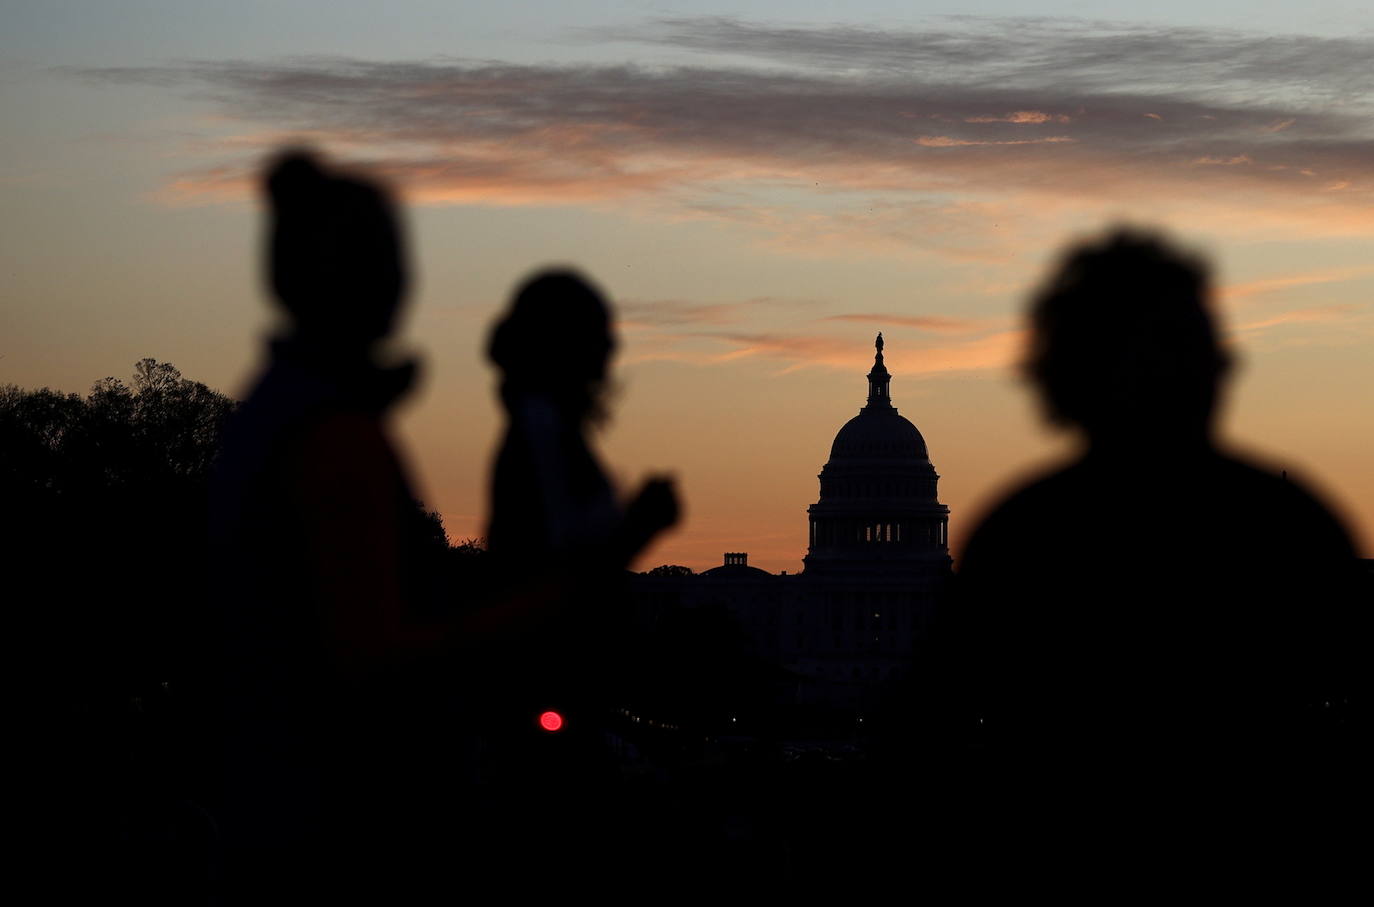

{"left": 1026, "top": 229, "right": 1227, "bottom": 445}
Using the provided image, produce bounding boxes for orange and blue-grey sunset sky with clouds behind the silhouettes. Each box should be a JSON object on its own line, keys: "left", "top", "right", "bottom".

{"left": 0, "top": 0, "right": 1374, "bottom": 572}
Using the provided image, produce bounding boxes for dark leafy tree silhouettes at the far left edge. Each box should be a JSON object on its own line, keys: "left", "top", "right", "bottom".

{"left": 0, "top": 359, "right": 235, "bottom": 695}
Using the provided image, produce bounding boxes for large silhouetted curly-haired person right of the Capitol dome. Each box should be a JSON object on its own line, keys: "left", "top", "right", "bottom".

{"left": 944, "top": 231, "right": 1367, "bottom": 881}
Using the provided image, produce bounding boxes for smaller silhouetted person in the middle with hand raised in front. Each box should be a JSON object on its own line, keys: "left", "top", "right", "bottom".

{"left": 488, "top": 271, "right": 677, "bottom": 881}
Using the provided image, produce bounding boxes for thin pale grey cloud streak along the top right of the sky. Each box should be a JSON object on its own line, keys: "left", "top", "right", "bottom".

{"left": 583, "top": 16, "right": 1374, "bottom": 103}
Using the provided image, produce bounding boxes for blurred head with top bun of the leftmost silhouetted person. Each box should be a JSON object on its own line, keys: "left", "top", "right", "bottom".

{"left": 265, "top": 151, "right": 407, "bottom": 348}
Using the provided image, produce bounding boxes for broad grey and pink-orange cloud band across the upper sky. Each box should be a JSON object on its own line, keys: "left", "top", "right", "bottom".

{"left": 67, "top": 18, "right": 1374, "bottom": 258}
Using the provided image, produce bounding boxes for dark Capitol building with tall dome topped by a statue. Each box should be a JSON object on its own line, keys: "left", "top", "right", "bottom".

{"left": 635, "top": 334, "right": 951, "bottom": 712}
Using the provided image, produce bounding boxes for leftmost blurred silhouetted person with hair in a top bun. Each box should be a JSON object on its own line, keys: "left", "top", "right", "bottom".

{"left": 212, "top": 154, "right": 442, "bottom": 903}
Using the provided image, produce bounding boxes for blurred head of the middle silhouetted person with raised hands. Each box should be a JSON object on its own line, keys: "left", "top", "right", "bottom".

{"left": 486, "top": 271, "right": 616, "bottom": 419}
